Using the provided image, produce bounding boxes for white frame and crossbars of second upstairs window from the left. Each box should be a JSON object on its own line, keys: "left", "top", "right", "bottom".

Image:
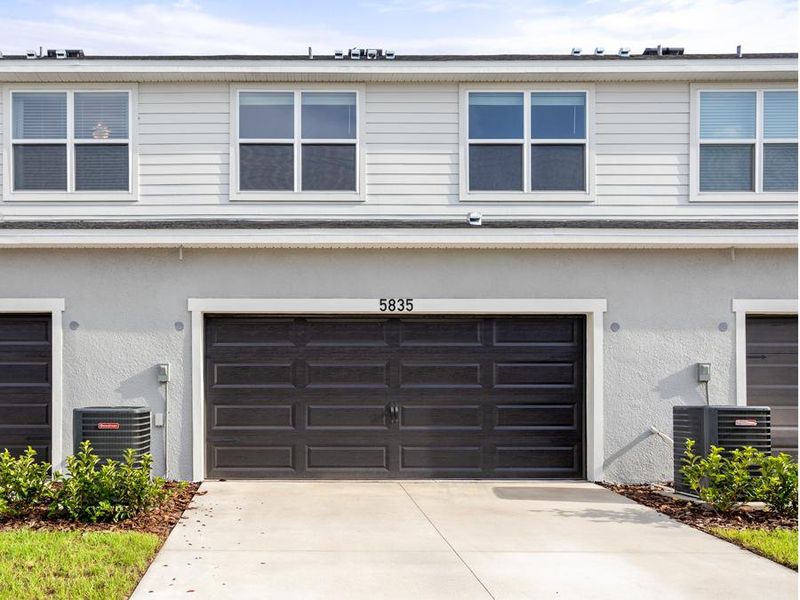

{"left": 230, "top": 84, "right": 366, "bottom": 203}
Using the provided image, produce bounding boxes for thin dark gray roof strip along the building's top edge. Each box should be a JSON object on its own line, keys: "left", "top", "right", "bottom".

{"left": 0, "top": 52, "right": 797, "bottom": 63}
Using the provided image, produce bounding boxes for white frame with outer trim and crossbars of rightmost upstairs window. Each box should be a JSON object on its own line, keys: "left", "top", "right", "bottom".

{"left": 689, "top": 83, "right": 798, "bottom": 203}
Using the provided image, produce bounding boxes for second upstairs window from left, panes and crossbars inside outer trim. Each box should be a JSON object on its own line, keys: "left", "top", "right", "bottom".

{"left": 238, "top": 91, "right": 358, "bottom": 192}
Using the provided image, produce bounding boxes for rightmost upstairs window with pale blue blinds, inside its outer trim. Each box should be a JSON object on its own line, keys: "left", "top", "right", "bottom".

{"left": 698, "top": 90, "right": 797, "bottom": 193}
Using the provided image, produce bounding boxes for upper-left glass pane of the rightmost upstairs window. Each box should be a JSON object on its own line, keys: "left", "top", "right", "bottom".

{"left": 700, "top": 92, "right": 757, "bottom": 140}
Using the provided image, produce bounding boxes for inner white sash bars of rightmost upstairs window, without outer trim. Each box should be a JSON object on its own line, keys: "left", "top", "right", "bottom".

{"left": 691, "top": 87, "right": 798, "bottom": 195}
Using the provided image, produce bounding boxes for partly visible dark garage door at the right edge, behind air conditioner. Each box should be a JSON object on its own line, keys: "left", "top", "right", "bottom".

{"left": 746, "top": 316, "right": 797, "bottom": 458}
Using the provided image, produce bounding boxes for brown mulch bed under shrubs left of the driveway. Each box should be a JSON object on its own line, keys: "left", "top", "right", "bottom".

{"left": 0, "top": 482, "right": 200, "bottom": 541}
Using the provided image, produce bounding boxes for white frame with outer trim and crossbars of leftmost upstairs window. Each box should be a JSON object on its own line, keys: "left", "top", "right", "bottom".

{"left": 2, "top": 84, "right": 139, "bottom": 203}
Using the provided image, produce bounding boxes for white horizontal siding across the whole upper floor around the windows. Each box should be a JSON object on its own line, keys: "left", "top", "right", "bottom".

{"left": 0, "top": 82, "right": 796, "bottom": 219}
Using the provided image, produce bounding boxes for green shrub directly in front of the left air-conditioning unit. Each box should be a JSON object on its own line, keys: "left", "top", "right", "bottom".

{"left": 50, "top": 440, "right": 166, "bottom": 523}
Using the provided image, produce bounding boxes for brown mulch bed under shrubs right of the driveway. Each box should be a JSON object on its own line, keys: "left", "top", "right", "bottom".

{"left": 600, "top": 483, "right": 797, "bottom": 532}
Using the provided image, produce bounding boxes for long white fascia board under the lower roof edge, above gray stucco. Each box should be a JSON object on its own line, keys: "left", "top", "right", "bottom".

{"left": 0, "top": 227, "right": 797, "bottom": 248}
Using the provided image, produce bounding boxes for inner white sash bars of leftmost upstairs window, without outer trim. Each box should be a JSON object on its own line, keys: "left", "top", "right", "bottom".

{"left": 9, "top": 88, "right": 134, "bottom": 196}
